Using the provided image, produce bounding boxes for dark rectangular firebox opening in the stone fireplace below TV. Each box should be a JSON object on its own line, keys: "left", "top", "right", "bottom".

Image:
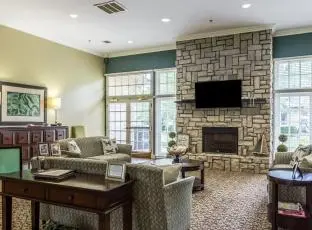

{"left": 203, "top": 127, "right": 238, "bottom": 154}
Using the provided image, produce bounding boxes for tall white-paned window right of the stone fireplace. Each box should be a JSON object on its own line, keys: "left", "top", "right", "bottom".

{"left": 274, "top": 58, "right": 312, "bottom": 151}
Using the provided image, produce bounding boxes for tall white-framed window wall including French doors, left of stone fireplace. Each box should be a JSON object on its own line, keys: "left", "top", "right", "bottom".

{"left": 106, "top": 69, "right": 176, "bottom": 156}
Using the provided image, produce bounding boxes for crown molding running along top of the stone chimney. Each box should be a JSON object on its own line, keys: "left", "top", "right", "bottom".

{"left": 177, "top": 24, "right": 275, "bottom": 41}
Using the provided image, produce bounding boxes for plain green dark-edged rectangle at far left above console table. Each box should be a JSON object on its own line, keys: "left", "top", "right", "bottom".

{"left": 0, "top": 147, "right": 23, "bottom": 173}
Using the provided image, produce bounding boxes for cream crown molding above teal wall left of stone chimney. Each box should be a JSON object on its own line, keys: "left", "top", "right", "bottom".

{"left": 106, "top": 43, "right": 176, "bottom": 58}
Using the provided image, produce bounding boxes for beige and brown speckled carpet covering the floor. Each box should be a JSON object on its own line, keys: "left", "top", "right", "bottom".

{"left": 0, "top": 170, "right": 271, "bottom": 230}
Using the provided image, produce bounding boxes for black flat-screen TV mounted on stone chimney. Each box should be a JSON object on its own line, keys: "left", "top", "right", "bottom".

{"left": 195, "top": 80, "right": 242, "bottom": 108}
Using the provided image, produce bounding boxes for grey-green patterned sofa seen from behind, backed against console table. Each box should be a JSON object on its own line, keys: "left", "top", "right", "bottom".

{"left": 35, "top": 158, "right": 194, "bottom": 230}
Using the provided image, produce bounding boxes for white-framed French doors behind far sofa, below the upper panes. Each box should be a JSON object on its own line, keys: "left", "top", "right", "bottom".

{"left": 108, "top": 101, "right": 152, "bottom": 152}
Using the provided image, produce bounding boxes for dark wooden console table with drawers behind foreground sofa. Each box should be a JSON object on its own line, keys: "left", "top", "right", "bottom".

{"left": 0, "top": 170, "right": 133, "bottom": 230}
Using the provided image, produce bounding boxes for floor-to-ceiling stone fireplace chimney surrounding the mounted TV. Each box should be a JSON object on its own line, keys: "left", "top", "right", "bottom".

{"left": 176, "top": 30, "right": 272, "bottom": 173}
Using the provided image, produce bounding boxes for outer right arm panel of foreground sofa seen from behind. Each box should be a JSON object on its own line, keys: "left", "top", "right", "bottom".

{"left": 164, "top": 176, "right": 195, "bottom": 230}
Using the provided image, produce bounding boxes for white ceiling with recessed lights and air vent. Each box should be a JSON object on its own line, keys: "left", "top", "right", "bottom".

{"left": 0, "top": 0, "right": 312, "bottom": 56}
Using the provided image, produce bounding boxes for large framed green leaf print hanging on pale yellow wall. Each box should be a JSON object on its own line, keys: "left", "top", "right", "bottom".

{"left": 0, "top": 82, "right": 47, "bottom": 125}
